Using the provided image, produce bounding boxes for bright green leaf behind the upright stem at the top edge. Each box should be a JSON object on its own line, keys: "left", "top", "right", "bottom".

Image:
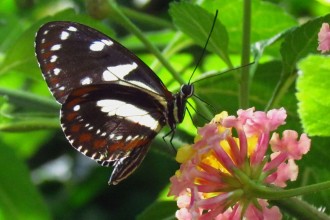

{"left": 203, "top": 0, "right": 297, "bottom": 53}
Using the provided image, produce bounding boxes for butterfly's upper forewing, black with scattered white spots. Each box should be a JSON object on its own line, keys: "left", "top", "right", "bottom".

{"left": 35, "top": 21, "right": 171, "bottom": 104}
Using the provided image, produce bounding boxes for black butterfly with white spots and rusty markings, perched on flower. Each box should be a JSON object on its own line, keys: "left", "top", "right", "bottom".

{"left": 35, "top": 21, "right": 194, "bottom": 185}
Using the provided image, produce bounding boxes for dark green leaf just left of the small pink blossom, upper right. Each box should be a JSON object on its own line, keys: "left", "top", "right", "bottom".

{"left": 280, "top": 14, "right": 330, "bottom": 75}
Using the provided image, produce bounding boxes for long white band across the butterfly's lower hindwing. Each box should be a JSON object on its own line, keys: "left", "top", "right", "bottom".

{"left": 96, "top": 99, "right": 160, "bottom": 131}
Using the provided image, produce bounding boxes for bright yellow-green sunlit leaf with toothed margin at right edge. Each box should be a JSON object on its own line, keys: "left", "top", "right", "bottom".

{"left": 297, "top": 55, "right": 330, "bottom": 136}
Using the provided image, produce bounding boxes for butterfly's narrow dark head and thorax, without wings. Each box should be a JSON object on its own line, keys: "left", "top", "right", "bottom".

{"left": 173, "top": 84, "right": 194, "bottom": 124}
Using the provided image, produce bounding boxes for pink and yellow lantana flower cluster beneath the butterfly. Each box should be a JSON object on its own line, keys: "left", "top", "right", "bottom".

{"left": 169, "top": 108, "right": 310, "bottom": 220}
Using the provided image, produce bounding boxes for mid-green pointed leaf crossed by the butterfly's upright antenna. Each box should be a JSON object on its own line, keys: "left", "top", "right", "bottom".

{"left": 169, "top": 2, "right": 231, "bottom": 66}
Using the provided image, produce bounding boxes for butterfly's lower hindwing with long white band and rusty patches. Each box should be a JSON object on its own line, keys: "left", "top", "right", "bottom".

{"left": 61, "top": 83, "right": 166, "bottom": 184}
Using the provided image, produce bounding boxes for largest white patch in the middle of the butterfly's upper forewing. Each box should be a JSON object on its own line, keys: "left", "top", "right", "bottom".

{"left": 103, "top": 62, "right": 138, "bottom": 81}
